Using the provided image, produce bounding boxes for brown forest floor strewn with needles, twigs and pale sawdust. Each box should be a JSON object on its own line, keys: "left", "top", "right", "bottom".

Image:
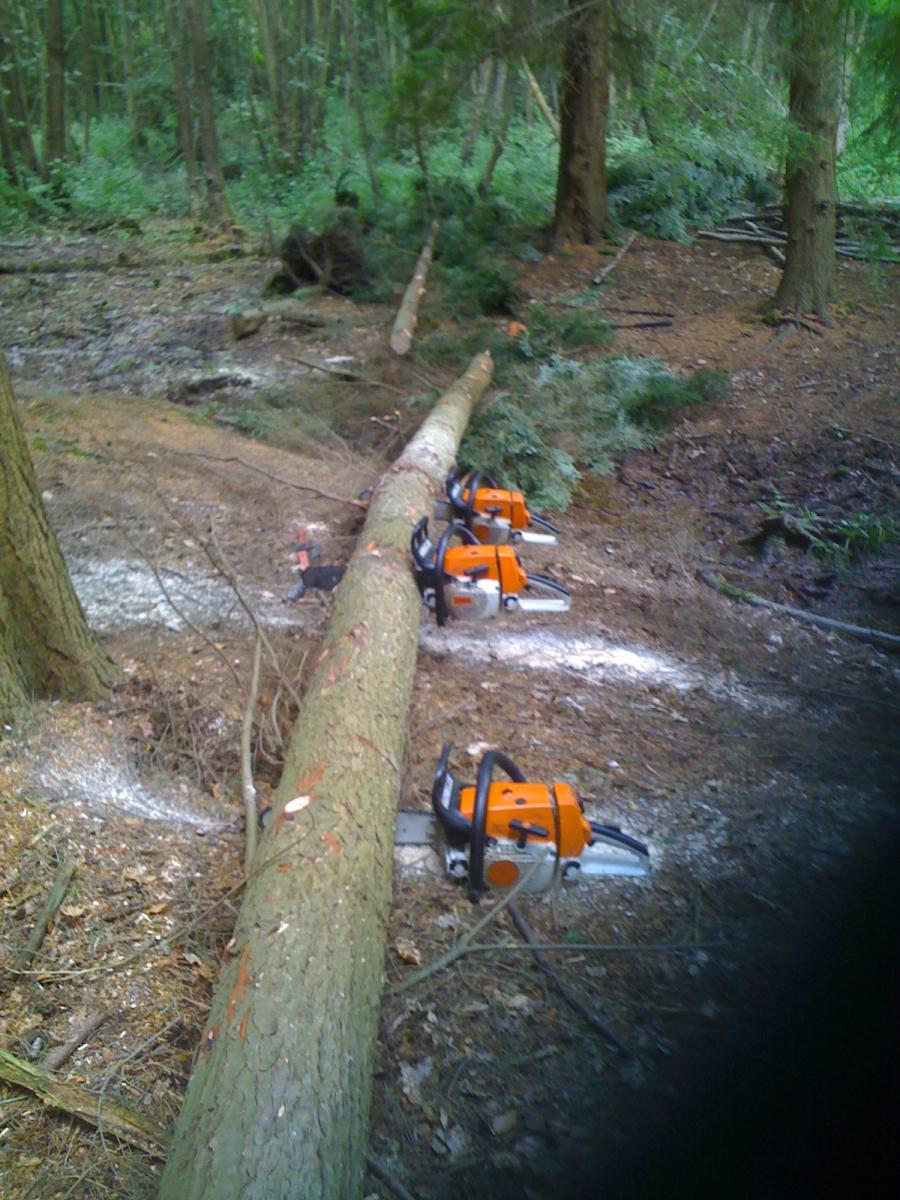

{"left": 0, "top": 223, "right": 900, "bottom": 1200}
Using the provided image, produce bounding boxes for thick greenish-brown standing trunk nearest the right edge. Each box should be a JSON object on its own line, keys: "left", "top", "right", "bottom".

{"left": 775, "top": 0, "right": 844, "bottom": 317}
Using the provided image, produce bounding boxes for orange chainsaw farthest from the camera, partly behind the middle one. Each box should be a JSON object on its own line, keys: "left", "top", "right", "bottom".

{"left": 434, "top": 467, "right": 559, "bottom": 546}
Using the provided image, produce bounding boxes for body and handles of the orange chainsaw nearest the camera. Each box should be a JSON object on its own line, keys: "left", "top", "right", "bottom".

{"left": 431, "top": 743, "right": 649, "bottom": 900}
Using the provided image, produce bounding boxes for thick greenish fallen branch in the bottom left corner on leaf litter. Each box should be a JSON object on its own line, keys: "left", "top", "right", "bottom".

{"left": 0, "top": 1050, "right": 169, "bottom": 1158}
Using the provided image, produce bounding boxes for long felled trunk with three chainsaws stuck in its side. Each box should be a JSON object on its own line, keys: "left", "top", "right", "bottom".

{"left": 161, "top": 353, "right": 493, "bottom": 1200}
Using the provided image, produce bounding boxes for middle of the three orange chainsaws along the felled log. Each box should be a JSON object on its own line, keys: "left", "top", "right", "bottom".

{"left": 409, "top": 517, "right": 571, "bottom": 625}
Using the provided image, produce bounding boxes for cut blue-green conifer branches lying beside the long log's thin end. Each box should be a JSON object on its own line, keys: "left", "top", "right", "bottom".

{"left": 461, "top": 355, "right": 730, "bottom": 510}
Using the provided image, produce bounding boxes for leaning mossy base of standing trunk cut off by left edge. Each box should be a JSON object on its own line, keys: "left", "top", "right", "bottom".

{"left": 0, "top": 353, "right": 114, "bottom": 721}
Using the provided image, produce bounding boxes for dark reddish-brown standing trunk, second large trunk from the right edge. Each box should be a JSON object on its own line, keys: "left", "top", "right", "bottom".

{"left": 553, "top": 0, "right": 610, "bottom": 242}
